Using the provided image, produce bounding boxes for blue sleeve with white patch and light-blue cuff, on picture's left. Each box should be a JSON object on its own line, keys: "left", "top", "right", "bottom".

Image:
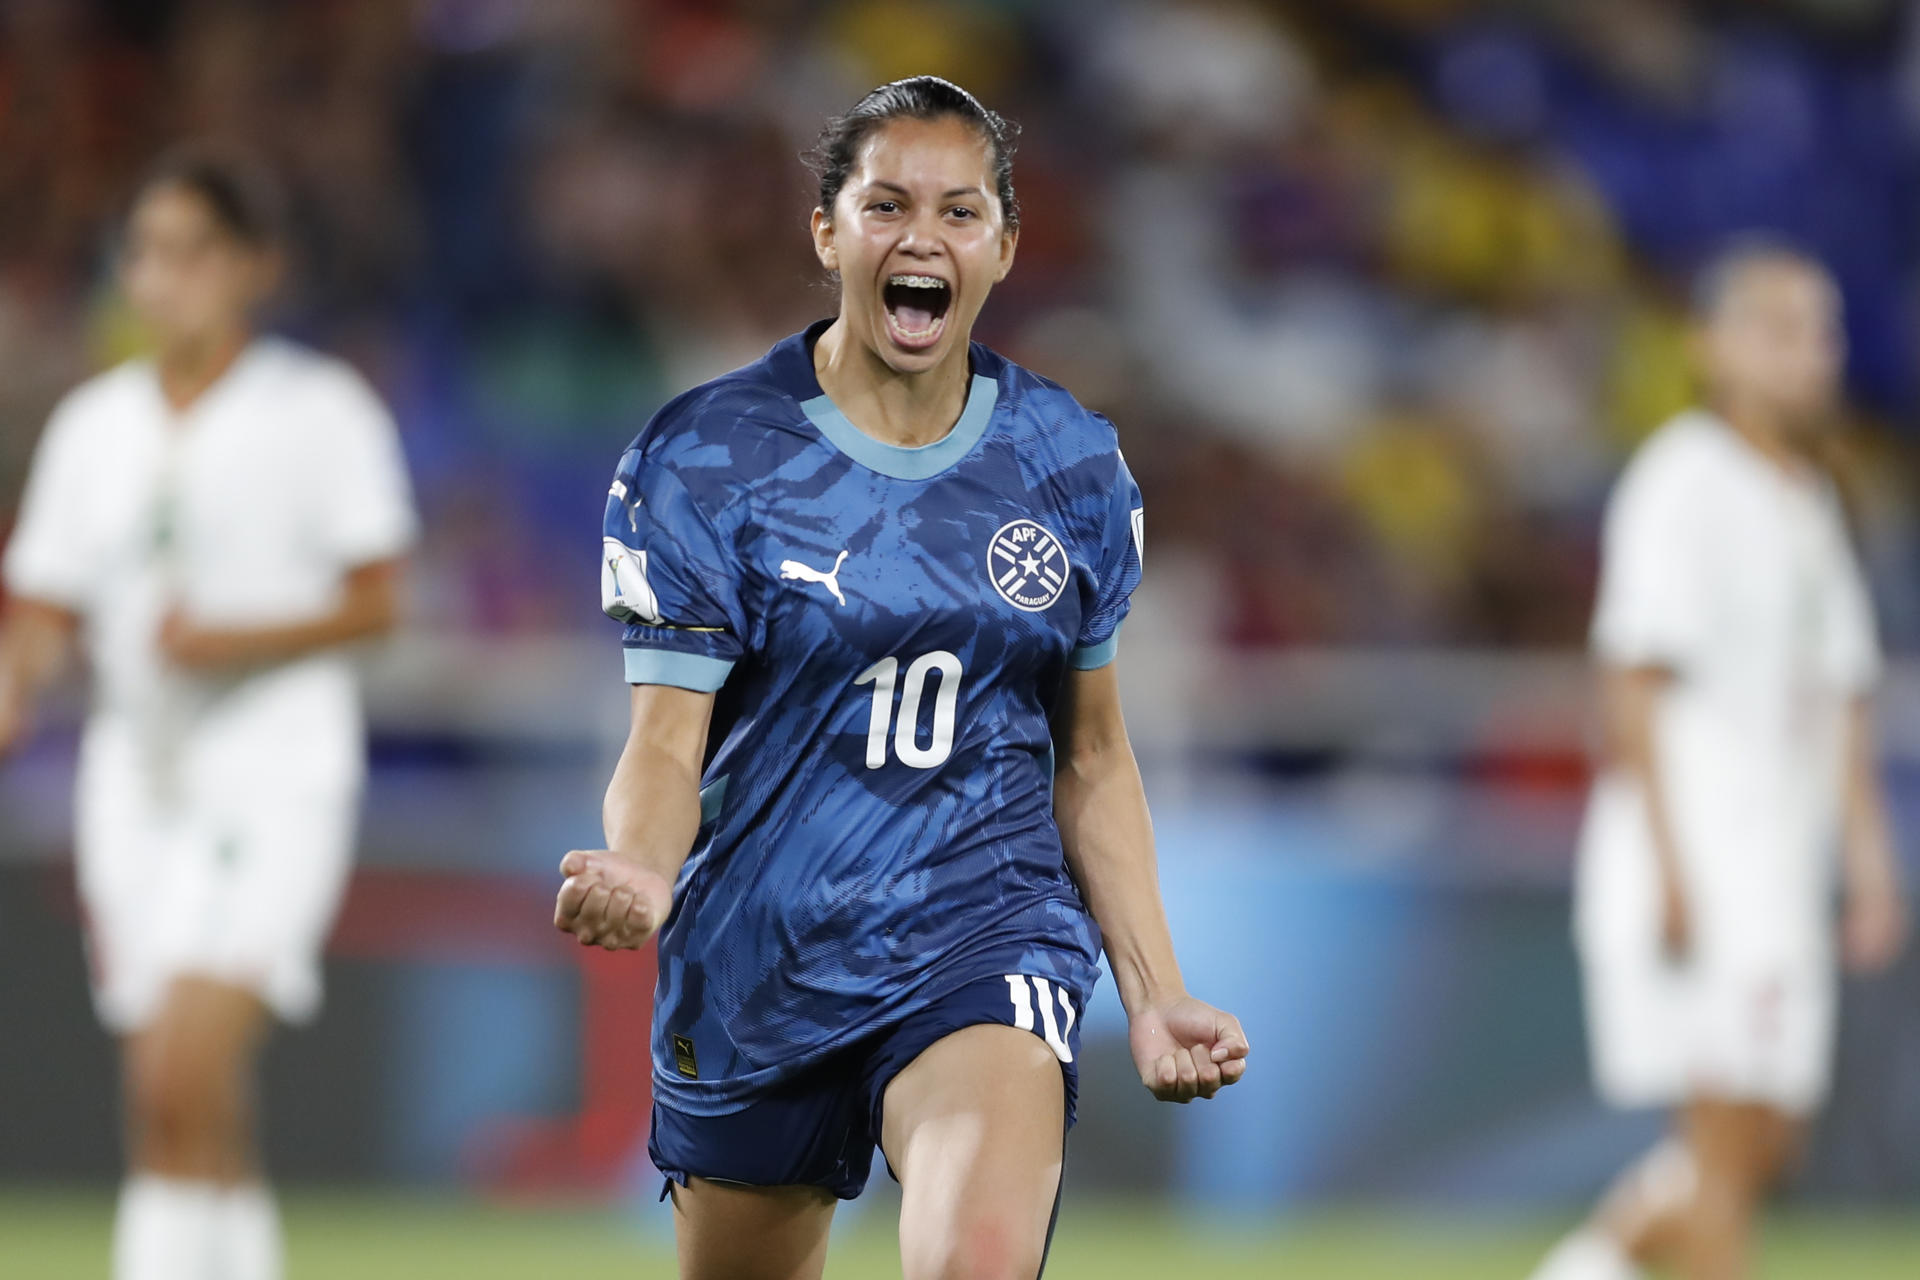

{"left": 601, "top": 449, "right": 747, "bottom": 693}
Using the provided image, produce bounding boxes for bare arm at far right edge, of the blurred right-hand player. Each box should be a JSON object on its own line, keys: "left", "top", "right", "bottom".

{"left": 1841, "top": 695, "right": 1908, "bottom": 973}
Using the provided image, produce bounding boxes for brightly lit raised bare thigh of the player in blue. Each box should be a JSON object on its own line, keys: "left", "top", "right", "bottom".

{"left": 881, "top": 1025, "right": 1066, "bottom": 1280}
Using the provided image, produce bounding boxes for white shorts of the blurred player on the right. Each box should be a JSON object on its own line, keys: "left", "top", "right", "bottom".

{"left": 1580, "top": 940, "right": 1837, "bottom": 1115}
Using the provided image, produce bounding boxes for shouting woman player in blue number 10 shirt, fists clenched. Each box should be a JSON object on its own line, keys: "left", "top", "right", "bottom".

{"left": 555, "top": 77, "right": 1248, "bottom": 1280}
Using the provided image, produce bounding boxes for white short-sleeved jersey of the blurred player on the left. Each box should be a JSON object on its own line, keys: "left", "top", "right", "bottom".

{"left": 4, "top": 338, "right": 415, "bottom": 806}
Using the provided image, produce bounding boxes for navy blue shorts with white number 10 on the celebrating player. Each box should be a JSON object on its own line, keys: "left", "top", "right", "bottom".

{"left": 647, "top": 973, "right": 1085, "bottom": 1199}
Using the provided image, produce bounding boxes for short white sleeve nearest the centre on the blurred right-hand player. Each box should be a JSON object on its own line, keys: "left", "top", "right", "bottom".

{"left": 1592, "top": 445, "right": 1707, "bottom": 672}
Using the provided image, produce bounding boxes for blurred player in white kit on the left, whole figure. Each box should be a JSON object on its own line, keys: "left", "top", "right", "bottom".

{"left": 0, "top": 150, "right": 415, "bottom": 1280}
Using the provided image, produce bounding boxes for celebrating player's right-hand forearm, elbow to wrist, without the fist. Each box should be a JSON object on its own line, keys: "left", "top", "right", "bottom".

{"left": 1054, "top": 735, "right": 1187, "bottom": 1015}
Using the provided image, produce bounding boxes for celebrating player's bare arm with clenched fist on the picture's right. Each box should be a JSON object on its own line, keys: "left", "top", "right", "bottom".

{"left": 1054, "top": 662, "right": 1248, "bottom": 1102}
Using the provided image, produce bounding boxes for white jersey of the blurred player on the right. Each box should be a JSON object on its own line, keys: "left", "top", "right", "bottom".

{"left": 1578, "top": 413, "right": 1880, "bottom": 967}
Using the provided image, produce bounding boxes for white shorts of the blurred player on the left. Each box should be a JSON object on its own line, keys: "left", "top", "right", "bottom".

{"left": 75, "top": 733, "right": 359, "bottom": 1034}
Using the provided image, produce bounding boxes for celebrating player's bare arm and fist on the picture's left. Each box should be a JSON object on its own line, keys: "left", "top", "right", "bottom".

{"left": 553, "top": 685, "right": 714, "bottom": 952}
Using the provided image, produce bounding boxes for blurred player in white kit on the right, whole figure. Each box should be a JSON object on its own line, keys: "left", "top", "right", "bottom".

{"left": 1536, "top": 242, "right": 1907, "bottom": 1280}
